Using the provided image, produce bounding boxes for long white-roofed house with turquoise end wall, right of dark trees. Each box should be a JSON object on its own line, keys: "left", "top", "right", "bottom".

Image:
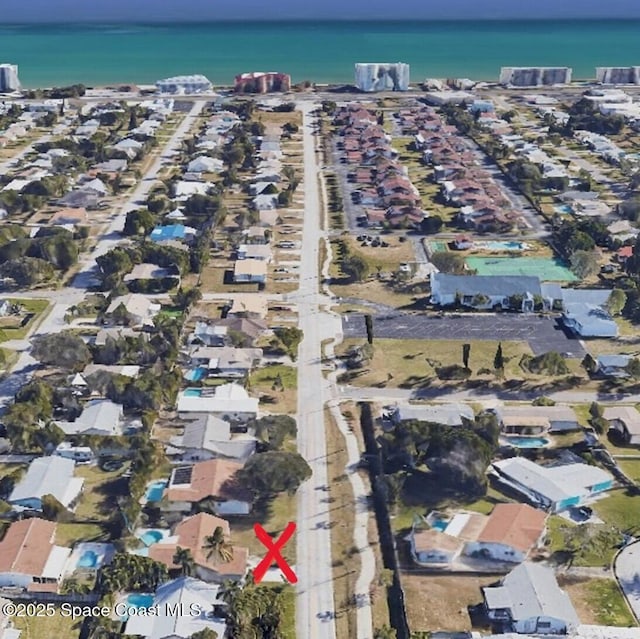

{"left": 491, "top": 457, "right": 613, "bottom": 512}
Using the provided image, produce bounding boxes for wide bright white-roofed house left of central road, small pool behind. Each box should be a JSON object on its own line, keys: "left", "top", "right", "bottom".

{"left": 177, "top": 384, "right": 258, "bottom": 423}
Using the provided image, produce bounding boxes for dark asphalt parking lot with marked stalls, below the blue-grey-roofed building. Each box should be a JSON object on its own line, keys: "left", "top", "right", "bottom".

{"left": 342, "top": 313, "right": 586, "bottom": 358}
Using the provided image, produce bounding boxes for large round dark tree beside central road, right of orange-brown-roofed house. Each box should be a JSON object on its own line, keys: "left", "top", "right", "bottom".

{"left": 237, "top": 451, "right": 311, "bottom": 497}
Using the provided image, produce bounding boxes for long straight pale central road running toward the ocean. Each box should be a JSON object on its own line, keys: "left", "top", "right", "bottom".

{"left": 289, "top": 103, "right": 336, "bottom": 639}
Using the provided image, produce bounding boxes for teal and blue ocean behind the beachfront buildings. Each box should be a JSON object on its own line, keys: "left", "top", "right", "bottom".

{"left": 0, "top": 20, "right": 640, "bottom": 88}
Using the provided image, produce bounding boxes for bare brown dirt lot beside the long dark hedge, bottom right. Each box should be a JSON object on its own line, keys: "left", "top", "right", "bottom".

{"left": 402, "top": 574, "right": 498, "bottom": 632}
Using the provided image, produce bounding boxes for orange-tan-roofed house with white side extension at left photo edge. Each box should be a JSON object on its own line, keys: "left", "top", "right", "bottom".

{"left": 0, "top": 518, "right": 71, "bottom": 593}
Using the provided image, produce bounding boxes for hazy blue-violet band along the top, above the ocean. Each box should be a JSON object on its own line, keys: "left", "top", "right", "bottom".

{"left": 0, "top": 0, "right": 640, "bottom": 24}
